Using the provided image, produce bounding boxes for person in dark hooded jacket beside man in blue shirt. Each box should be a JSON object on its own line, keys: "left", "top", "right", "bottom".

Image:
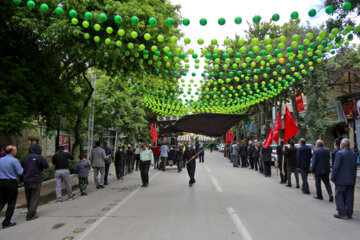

{"left": 21, "top": 144, "right": 49, "bottom": 221}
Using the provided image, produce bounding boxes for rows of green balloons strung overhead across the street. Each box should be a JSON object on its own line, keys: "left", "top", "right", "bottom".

{"left": 12, "top": 0, "right": 360, "bottom": 116}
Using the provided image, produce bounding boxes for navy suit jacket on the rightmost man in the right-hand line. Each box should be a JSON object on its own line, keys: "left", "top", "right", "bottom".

{"left": 331, "top": 148, "right": 357, "bottom": 186}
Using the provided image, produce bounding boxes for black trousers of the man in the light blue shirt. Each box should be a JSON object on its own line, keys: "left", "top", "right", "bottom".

{"left": 0, "top": 179, "right": 18, "bottom": 226}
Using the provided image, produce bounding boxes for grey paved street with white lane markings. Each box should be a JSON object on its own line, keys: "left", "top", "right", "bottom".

{"left": 0, "top": 152, "right": 360, "bottom": 240}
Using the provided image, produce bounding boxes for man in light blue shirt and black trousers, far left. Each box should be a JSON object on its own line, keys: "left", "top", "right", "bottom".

{"left": 0, "top": 145, "right": 23, "bottom": 228}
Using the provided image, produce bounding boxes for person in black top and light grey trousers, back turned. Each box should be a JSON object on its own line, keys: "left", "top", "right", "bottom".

{"left": 52, "top": 146, "right": 76, "bottom": 203}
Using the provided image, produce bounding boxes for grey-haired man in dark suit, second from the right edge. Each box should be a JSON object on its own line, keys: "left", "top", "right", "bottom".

{"left": 311, "top": 139, "right": 334, "bottom": 202}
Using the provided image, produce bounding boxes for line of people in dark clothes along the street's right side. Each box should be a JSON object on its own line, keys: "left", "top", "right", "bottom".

{"left": 225, "top": 138, "right": 357, "bottom": 219}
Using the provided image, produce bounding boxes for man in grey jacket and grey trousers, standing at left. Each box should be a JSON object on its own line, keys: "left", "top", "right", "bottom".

{"left": 90, "top": 142, "right": 106, "bottom": 189}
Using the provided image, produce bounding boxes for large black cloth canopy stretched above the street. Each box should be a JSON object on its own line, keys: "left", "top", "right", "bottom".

{"left": 163, "top": 113, "right": 246, "bottom": 137}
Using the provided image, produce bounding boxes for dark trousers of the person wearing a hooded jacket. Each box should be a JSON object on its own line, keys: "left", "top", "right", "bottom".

{"left": 25, "top": 183, "right": 41, "bottom": 218}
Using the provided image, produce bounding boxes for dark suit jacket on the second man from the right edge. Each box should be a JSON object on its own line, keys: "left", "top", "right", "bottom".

{"left": 311, "top": 147, "right": 330, "bottom": 174}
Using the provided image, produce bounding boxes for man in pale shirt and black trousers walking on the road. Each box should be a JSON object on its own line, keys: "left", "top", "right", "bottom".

{"left": 135, "top": 145, "right": 154, "bottom": 187}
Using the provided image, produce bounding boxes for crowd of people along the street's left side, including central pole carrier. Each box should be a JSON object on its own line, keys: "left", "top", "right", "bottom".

{"left": 0, "top": 141, "right": 204, "bottom": 228}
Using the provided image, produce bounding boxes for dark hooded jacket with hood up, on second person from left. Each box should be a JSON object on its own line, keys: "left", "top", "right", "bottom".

{"left": 21, "top": 144, "right": 49, "bottom": 183}
